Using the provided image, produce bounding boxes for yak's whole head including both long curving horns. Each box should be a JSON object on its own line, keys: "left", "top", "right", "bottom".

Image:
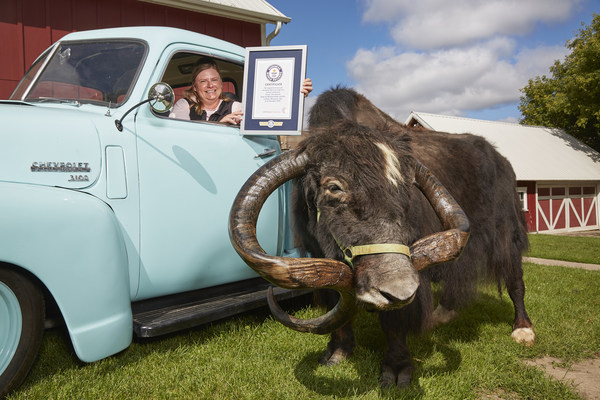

{"left": 230, "top": 121, "right": 469, "bottom": 333}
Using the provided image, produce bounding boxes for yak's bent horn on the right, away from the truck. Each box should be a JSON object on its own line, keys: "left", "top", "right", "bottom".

{"left": 410, "top": 163, "right": 470, "bottom": 270}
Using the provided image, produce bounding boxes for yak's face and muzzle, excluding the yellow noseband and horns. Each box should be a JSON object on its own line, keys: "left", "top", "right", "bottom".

{"left": 301, "top": 133, "right": 419, "bottom": 310}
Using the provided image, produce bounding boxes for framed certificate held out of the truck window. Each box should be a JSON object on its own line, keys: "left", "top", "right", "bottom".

{"left": 240, "top": 45, "right": 307, "bottom": 135}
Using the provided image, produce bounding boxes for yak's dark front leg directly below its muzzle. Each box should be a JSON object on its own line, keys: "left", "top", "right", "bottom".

{"left": 379, "top": 310, "right": 415, "bottom": 387}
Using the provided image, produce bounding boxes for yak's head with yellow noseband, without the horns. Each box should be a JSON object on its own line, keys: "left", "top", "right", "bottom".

{"left": 294, "top": 122, "right": 419, "bottom": 309}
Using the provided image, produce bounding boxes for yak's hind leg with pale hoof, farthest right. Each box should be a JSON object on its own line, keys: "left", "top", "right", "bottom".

{"left": 504, "top": 252, "right": 535, "bottom": 346}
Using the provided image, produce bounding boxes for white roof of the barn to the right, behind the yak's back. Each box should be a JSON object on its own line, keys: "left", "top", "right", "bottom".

{"left": 406, "top": 112, "right": 600, "bottom": 181}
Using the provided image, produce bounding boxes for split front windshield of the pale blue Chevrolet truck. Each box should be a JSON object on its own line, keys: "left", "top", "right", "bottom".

{"left": 11, "top": 41, "right": 146, "bottom": 107}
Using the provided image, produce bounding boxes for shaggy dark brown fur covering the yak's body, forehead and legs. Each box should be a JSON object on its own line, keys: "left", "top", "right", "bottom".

{"left": 293, "top": 88, "right": 532, "bottom": 386}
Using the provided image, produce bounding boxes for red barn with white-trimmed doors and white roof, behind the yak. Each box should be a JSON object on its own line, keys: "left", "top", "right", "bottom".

{"left": 406, "top": 112, "right": 600, "bottom": 233}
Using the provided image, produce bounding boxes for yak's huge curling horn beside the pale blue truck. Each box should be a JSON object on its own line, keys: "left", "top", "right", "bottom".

{"left": 229, "top": 151, "right": 356, "bottom": 334}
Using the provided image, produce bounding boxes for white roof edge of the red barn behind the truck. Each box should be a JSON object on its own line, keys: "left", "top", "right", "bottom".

{"left": 142, "top": 0, "right": 292, "bottom": 24}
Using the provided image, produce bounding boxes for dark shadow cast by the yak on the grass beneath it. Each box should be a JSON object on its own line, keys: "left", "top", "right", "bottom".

{"left": 294, "top": 293, "right": 514, "bottom": 399}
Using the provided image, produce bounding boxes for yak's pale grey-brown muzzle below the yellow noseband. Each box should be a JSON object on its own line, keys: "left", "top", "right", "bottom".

{"left": 355, "top": 254, "right": 419, "bottom": 309}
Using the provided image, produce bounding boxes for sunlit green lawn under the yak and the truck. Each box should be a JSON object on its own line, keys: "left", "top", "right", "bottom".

{"left": 9, "top": 264, "right": 600, "bottom": 400}
